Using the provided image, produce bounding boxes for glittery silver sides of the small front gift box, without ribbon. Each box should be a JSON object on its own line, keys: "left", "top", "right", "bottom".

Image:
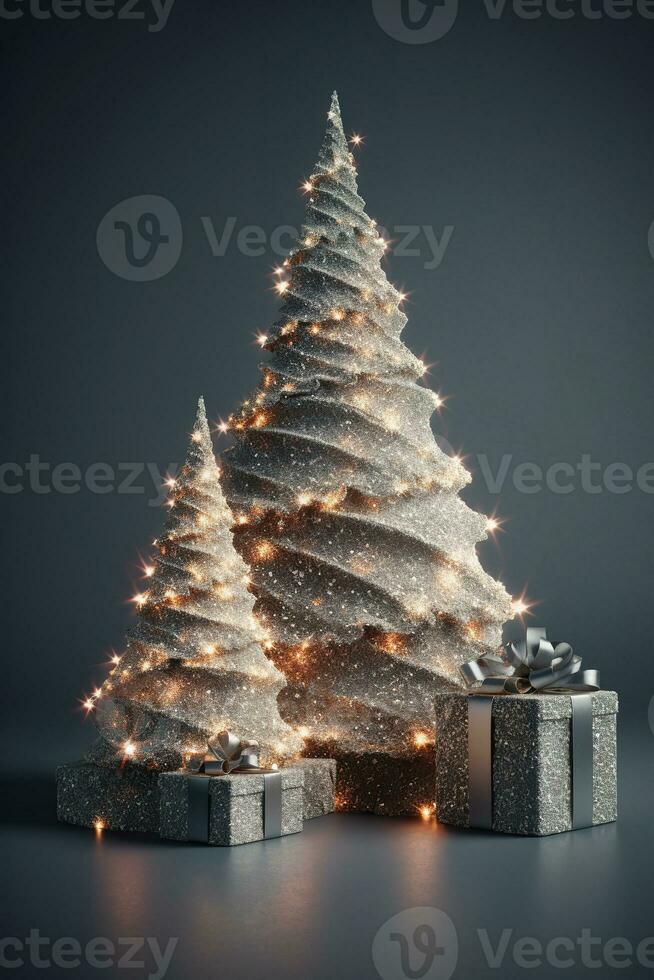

{"left": 159, "top": 766, "right": 304, "bottom": 847}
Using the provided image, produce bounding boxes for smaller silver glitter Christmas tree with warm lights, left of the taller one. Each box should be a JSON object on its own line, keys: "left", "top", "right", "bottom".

{"left": 87, "top": 399, "right": 302, "bottom": 769}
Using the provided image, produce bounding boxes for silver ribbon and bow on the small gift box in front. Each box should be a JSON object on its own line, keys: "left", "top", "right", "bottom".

{"left": 186, "top": 732, "right": 282, "bottom": 844}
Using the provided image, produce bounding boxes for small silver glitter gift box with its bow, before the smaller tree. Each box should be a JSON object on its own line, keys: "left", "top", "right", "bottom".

{"left": 159, "top": 732, "right": 304, "bottom": 847}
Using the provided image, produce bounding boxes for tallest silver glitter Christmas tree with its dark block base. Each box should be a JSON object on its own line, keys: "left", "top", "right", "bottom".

{"left": 223, "top": 94, "right": 512, "bottom": 814}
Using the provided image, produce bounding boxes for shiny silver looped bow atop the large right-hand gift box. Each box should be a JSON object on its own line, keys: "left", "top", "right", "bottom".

{"left": 461, "top": 626, "right": 600, "bottom": 694}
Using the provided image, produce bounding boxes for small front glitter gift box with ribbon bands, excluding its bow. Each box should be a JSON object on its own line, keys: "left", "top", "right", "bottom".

{"left": 159, "top": 766, "right": 304, "bottom": 847}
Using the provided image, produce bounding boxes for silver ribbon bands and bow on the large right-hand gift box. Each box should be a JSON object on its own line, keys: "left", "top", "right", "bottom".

{"left": 461, "top": 627, "right": 600, "bottom": 830}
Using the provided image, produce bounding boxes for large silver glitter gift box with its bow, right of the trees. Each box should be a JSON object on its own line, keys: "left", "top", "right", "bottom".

{"left": 436, "top": 629, "right": 618, "bottom": 836}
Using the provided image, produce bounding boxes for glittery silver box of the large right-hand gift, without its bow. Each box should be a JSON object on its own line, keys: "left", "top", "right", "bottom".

{"left": 436, "top": 691, "right": 618, "bottom": 836}
